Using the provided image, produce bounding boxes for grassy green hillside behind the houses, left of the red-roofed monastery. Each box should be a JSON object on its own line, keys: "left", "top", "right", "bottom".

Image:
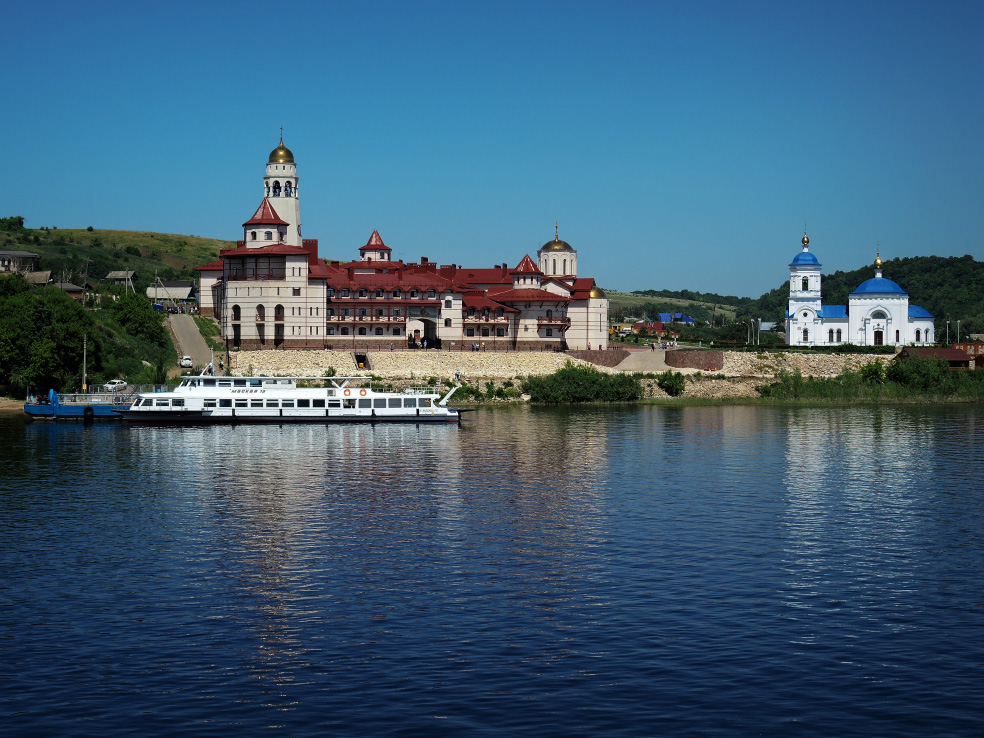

{"left": 0, "top": 216, "right": 236, "bottom": 291}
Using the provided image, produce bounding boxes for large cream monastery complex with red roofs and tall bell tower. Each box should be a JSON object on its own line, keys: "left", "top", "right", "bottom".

{"left": 198, "top": 135, "right": 608, "bottom": 351}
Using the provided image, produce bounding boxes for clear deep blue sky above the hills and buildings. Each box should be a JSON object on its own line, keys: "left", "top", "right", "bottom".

{"left": 0, "top": 0, "right": 984, "bottom": 297}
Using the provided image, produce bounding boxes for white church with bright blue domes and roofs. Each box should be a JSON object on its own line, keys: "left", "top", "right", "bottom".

{"left": 786, "top": 234, "right": 935, "bottom": 347}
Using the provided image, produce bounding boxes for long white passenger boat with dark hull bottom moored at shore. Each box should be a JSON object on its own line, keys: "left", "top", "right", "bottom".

{"left": 118, "top": 376, "right": 461, "bottom": 423}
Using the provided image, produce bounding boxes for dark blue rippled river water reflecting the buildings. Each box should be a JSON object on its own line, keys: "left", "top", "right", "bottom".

{"left": 0, "top": 407, "right": 984, "bottom": 736}
